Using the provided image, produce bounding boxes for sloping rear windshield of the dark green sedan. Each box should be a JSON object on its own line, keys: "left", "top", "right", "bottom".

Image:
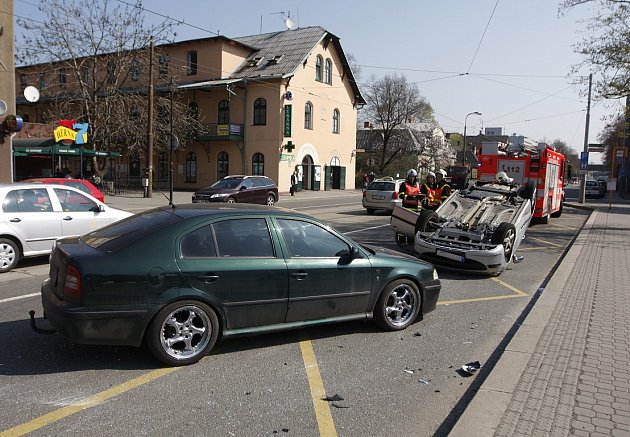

{"left": 81, "top": 210, "right": 182, "bottom": 252}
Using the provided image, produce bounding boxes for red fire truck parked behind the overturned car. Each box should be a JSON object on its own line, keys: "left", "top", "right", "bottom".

{"left": 472, "top": 143, "right": 567, "bottom": 223}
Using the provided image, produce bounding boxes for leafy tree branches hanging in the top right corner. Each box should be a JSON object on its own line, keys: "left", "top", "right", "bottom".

{"left": 560, "top": 0, "right": 630, "bottom": 98}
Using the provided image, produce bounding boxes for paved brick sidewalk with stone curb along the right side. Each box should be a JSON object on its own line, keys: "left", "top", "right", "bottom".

{"left": 449, "top": 196, "right": 630, "bottom": 437}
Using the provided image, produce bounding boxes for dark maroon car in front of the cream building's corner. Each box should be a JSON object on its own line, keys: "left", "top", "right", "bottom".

{"left": 192, "top": 175, "right": 278, "bottom": 206}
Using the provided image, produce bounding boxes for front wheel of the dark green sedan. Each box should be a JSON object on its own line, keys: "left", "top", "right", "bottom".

{"left": 374, "top": 279, "right": 421, "bottom": 331}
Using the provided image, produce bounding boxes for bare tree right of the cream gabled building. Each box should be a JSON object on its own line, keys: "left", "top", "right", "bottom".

{"left": 364, "top": 74, "right": 433, "bottom": 174}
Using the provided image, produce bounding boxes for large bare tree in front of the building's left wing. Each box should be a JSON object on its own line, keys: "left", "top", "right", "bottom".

{"left": 17, "top": 0, "right": 205, "bottom": 174}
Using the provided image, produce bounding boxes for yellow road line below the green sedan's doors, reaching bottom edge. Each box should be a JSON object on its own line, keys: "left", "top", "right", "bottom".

{"left": 300, "top": 331, "right": 337, "bottom": 437}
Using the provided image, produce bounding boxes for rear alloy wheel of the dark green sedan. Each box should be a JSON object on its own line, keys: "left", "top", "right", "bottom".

{"left": 146, "top": 300, "right": 219, "bottom": 366}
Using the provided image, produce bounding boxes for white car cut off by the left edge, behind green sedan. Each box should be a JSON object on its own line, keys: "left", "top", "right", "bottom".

{"left": 0, "top": 183, "right": 132, "bottom": 273}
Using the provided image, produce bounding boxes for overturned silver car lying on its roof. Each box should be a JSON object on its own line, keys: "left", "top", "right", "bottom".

{"left": 391, "top": 182, "right": 535, "bottom": 275}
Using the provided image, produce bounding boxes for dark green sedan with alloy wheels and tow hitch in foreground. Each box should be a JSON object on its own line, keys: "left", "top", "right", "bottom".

{"left": 41, "top": 204, "right": 441, "bottom": 366}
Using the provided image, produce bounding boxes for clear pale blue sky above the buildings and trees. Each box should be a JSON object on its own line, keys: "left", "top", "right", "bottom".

{"left": 14, "top": 0, "right": 623, "bottom": 162}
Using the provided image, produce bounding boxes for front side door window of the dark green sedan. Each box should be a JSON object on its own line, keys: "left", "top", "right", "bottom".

{"left": 278, "top": 219, "right": 349, "bottom": 258}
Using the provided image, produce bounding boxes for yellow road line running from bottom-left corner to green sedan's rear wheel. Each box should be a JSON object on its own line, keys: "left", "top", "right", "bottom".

{"left": 0, "top": 367, "right": 177, "bottom": 437}
